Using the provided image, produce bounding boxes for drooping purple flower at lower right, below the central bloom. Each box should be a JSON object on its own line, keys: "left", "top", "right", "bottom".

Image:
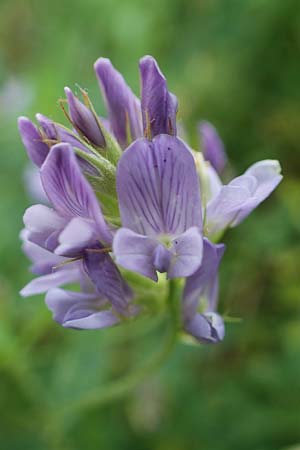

{"left": 182, "top": 238, "right": 225, "bottom": 343}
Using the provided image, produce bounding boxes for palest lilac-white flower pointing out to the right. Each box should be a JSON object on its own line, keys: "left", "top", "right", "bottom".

{"left": 205, "top": 160, "right": 282, "bottom": 236}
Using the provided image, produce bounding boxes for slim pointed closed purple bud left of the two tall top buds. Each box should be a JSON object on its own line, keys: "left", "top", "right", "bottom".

{"left": 65, "top": 87, "right": 106, "bottom": 148}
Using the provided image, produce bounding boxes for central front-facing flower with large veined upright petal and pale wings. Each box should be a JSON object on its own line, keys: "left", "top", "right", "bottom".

{"left": 113, "top": 135, "right": 202, "bottom": 281}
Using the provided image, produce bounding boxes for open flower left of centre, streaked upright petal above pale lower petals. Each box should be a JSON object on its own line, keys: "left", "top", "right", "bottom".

{"left": 24, "top": 144, "right": 112, "bottom": 257}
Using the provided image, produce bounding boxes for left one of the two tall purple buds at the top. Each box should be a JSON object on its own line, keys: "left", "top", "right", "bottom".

{"left": 94, "top": 58, "right": 143, "bottom": 148}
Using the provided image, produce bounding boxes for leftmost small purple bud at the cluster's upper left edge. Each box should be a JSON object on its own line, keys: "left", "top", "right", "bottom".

{"left": 18, "top": 117, "right": 49, "bottom": 167}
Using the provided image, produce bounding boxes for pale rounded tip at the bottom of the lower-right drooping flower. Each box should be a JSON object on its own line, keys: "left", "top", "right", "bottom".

{"left": 185, "top": 313, "right": 225, "bottom": 344}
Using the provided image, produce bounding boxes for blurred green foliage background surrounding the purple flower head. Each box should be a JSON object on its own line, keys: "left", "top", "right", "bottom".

{"left": 0, "top": 0, "right": 300, "bottom": 450}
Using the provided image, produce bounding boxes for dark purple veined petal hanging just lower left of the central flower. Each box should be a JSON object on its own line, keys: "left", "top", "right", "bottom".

{"left": 84, "top": 251, "right": 132, "bottom": 314}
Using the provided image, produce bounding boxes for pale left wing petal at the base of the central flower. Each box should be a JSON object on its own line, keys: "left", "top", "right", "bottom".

{"left": 113, "top": 228, "right": 158, "bottom": 281}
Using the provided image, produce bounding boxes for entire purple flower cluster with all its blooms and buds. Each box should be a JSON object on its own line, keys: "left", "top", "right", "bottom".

{"left": 19, "top": 56, "right": 282, "bottom": 343}
